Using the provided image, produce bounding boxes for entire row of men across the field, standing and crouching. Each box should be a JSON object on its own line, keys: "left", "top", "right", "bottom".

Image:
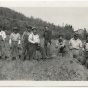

{"left": 0, "top": 26, "right": 88, "bottom": 60}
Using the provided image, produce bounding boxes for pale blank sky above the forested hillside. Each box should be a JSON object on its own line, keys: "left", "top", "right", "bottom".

{"left": 9, "top": 7, "right": 88, "bottom": 30}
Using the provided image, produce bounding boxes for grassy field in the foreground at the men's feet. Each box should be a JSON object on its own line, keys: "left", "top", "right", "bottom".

{"left": 0, "top": 36, "right": 88, "bottom": 81}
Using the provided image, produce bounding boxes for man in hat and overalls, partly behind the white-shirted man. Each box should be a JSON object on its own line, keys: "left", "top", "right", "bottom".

{"left": 22, "top": 26, "right": 32, "bottom": 60}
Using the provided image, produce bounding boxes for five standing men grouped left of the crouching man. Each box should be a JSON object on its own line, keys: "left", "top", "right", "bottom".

{"left": 0, "top": 26, "right": 52, "bottom": 60}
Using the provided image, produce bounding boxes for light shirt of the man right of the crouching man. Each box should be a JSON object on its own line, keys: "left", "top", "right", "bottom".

{"left": 69, "top": 38, "right": 82, "bottom": 49}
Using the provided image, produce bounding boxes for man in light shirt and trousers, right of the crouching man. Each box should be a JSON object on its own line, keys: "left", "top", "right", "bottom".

{"left": 69, "top": 33, "right": 82, "bottom": 58}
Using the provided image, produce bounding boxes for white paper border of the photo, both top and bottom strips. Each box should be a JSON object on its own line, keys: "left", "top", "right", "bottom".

{"left": 0, "top": 0, "right": 88, "bottom": 87}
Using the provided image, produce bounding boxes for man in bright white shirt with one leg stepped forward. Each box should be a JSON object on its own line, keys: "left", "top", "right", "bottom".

{"left": 28, "top": 28, "right": 46, "bottom": 59}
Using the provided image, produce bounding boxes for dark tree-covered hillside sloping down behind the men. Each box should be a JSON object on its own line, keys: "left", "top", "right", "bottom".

{"left": 0, "top": 7, "right": 86, "bottom": 39}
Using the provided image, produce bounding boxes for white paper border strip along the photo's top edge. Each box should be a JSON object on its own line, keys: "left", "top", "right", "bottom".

{"left": 0, "top": 0, "right": 88, "bottom": 7}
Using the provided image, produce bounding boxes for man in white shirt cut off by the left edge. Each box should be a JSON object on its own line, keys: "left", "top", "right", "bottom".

{"left": 0, "top": 27, "right": 6, "bottom": 59}
